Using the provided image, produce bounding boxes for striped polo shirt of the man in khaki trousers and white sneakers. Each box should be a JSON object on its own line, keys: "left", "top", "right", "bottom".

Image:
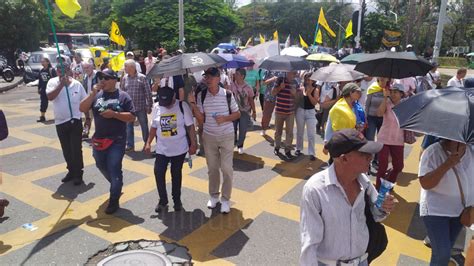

{"left": 197, "top": 87, "right": 239, "bottom": 136}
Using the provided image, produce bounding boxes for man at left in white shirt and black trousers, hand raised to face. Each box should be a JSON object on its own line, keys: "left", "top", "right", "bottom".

{"left": 46, "top": 63, "right": 87, "bottom": 186}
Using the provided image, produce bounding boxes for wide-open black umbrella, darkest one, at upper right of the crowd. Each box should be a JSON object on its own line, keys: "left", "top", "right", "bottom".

{"left": 355, "top": 51, "right": 433, "bottom": 79}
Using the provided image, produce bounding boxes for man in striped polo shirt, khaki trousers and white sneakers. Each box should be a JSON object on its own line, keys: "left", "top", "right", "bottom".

{"left": 190, "top": 67, "right": 240, "bottom": 213}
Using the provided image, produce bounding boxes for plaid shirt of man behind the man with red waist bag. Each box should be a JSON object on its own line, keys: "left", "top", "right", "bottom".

{"left": 120, "top": 73, "right": 153, "bottom": 111}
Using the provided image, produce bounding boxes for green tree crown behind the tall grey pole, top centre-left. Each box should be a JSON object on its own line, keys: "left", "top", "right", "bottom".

{"left": 112, "top": 0, "right": 241, "bottom": 50}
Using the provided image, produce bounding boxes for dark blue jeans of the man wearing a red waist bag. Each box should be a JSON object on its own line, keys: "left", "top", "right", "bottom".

{"left": 92, "top": 140, "right": 125, "bottom": 200}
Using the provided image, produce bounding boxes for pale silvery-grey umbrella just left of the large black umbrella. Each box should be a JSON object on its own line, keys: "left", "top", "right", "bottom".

{"left": 310, "top": 64, "right": 364, "bottom": 82}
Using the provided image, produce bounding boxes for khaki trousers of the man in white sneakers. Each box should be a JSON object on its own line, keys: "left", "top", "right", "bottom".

{"left": 202, "top": 132, "right": 234, "bottom": 200}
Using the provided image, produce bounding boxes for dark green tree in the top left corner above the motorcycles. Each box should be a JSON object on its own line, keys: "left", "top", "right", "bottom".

{"left": 0, "top": 0, "right": 48, "bottom": 60}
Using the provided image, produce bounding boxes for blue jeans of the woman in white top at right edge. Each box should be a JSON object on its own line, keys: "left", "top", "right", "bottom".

{"left": 422, "top": 216, "right": 462, "bottom": 266}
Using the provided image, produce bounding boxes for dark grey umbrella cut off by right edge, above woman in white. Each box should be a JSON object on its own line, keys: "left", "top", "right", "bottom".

{"left": 393, "top": 87, "right": 474, "bottom": 144}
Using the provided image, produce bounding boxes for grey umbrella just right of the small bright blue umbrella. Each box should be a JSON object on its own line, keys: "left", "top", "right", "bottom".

{"left": 259, "top": 55, "right": 310, "bottom": 72}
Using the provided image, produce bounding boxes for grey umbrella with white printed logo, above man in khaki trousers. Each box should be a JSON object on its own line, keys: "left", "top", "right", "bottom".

{"left": 147, "top": 53, "right": 227, "bottom": 78}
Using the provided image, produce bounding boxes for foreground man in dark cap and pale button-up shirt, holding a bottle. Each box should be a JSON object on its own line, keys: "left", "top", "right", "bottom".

{"left": 300, "top": 129, "right": 396, "bottom": 266}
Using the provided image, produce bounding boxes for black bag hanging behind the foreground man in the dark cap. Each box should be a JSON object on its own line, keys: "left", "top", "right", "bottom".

{"left": 364, "top": 193, "right": 388, "bottom": 264}
